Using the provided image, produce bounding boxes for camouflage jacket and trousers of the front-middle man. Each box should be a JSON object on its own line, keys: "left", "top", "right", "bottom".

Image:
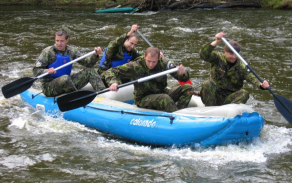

{"left": 103, "top": 57, "right": 193, "bottom": 112}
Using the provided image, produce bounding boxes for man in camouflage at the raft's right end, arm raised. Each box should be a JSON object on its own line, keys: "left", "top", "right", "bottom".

{"left": 200, "top": 32, "right": 270, "bottom": 106}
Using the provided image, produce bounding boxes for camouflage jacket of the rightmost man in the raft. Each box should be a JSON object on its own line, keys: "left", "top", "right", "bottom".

{"left": 200, "top": 43, "right": 260, "bottom": 92}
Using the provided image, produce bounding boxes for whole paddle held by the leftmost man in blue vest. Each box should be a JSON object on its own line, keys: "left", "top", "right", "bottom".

{"left": 2, "top": 51, "right": 95, "bottom": 98}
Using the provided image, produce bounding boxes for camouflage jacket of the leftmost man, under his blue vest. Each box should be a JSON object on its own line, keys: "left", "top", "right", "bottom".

{"left": 33, "top": 45, "right": 99, "bottom": 84}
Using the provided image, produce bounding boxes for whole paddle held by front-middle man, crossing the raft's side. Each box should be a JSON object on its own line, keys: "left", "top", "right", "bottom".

{"left": 57, "top": 68, "right": 178, "bottom": 112}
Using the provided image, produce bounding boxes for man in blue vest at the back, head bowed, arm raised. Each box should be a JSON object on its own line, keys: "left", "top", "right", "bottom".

{"left": 98, "top": 24, "right": 142, "bottom": 74}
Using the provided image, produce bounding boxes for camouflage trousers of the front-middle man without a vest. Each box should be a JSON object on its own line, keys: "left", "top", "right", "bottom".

{"left": 136, "top": 84, "right": 193, "bottom": 112}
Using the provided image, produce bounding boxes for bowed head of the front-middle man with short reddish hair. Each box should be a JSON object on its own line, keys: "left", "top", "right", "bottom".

{"left": 144, "top": 47, "right": 160, "bottom": 69}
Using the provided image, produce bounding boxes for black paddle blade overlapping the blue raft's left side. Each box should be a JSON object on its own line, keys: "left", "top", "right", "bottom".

{"left": 57, "top": 90, "right": 97, "bottom": 112}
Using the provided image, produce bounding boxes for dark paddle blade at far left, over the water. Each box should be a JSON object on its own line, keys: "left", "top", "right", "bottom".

{"left": 2, "top": 77, "right": 38, "bottom": 98}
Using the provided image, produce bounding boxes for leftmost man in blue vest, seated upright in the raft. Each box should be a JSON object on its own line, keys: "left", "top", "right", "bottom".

{"left": 33, "top": 30, "right": 105, "bottom": 97}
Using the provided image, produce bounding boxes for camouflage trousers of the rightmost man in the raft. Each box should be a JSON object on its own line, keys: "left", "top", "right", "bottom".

{"left": 201, "top": 80, "right": 249, "bottom": 106}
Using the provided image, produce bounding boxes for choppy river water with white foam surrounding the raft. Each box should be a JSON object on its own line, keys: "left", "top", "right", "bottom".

{"left": 0, "top": 6, "right": 292, "bottom": 183}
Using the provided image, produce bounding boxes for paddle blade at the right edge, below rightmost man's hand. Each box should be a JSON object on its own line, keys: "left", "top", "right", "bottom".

{"left": 273, "top": 94, "right": 292, "bottom": 124}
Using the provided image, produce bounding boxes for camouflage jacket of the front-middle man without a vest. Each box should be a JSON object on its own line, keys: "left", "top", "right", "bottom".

{"left": 102, "top": 57, "right": 189, "bottom": 103}
